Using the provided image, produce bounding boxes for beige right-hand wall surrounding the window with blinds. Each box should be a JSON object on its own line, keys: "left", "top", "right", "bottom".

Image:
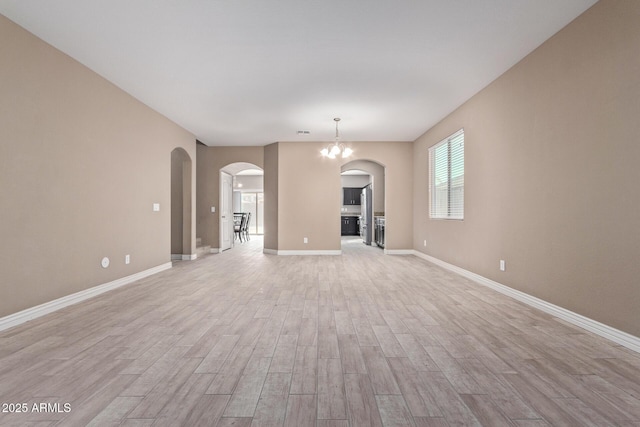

{"left": 413, "top": 0, "right": 640, "bottom": 336}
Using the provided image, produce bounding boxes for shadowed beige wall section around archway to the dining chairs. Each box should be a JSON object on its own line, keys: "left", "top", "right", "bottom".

{"left": 196, "top": 144, "right": 266, "bottom": 248}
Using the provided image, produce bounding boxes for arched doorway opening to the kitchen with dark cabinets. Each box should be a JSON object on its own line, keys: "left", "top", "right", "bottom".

{"left": 340, "top": 159, "right": 386, "bottom": 252}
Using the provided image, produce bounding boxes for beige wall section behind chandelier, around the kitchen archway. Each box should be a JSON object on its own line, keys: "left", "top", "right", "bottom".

{"left": 276, "top": 142, "right": 413, "bottom": 250}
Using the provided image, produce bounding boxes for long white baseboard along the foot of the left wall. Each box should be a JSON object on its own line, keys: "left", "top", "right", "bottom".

{"left": 0, "top": 262, "right": 172, "bottom": 331}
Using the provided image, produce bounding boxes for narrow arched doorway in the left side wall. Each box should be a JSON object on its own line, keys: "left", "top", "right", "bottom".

{"left": 171, "top": 148, "right": 196, "bottom": 260}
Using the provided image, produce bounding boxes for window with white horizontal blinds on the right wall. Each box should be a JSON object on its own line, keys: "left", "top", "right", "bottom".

{"left": 429, "top": 129, "right": 464, "bottom": 219}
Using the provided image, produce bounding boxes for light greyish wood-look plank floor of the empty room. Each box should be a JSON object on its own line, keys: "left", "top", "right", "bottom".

{"left": 0, "top": 236, "right": 640, "bottom": 427}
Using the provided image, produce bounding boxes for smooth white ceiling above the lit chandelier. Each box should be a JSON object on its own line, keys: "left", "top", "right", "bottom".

{"left": 0, "top": 0, "right": 595, "bottom": 145}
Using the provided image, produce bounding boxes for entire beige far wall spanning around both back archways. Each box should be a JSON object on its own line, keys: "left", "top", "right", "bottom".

{"left": 196, "top": 142, "right": 413, "bottom": 251}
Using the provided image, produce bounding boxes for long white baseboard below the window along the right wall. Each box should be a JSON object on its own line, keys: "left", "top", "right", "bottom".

{"left": 413, "top": 250, "right": 640, "bottom": 353}
